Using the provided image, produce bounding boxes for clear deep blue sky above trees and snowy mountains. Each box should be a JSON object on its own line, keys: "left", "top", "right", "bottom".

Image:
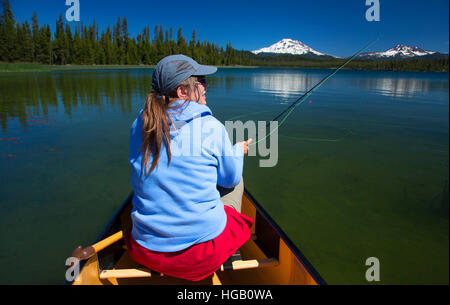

{"left": 10, "top": 0, "right": 449, "bottom": 56}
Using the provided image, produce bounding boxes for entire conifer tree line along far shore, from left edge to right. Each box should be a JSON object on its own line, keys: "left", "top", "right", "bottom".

{"left": 0, "top": 0, "right": 449, "bottom": 72}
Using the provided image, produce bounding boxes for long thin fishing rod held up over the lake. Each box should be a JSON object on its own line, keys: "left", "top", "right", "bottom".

{"left": 249, "top": 36, "right": 381, "bottom": 145}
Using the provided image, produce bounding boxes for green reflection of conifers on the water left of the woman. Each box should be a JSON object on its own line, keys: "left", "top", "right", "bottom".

{"left": 0, "top": 71, "right": 151, "bottom": 132}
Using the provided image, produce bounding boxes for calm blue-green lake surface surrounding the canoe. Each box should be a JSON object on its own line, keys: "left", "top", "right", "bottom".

{"left": 0, "top": 68, "right": 449, "bottom": 284}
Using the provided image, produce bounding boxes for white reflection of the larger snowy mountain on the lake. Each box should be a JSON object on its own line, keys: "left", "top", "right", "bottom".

{"left": 252, "top": 73, "right": 321, "bottom": 103}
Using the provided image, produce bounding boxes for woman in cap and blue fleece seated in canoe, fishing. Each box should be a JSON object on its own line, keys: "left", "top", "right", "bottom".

{"left": 126, "top": 55, "right": 253, "bottom": 281}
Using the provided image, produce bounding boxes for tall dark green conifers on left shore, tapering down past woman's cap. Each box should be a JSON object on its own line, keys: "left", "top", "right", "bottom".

{"left": 0, "top": 0, "right": 249, "bottom": 65}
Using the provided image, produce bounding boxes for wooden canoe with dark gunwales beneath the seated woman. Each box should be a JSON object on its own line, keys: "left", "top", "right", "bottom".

{"left": 65, "top": 189, "right": 326, "bottom": 285}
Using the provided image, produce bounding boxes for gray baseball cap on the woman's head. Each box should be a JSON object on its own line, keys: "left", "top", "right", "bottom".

{"left": 152, "top": 55, "right": 217, "bottom": 95}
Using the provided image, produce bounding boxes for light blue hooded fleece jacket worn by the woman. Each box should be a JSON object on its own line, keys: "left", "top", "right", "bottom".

{"left": 129, "top": 100, "right": 244, "bottom": 252}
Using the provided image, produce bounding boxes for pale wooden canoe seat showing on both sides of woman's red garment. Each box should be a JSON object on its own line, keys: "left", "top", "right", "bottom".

{"left": 99, "top": 236, "right": 278, "bottom": 279}
